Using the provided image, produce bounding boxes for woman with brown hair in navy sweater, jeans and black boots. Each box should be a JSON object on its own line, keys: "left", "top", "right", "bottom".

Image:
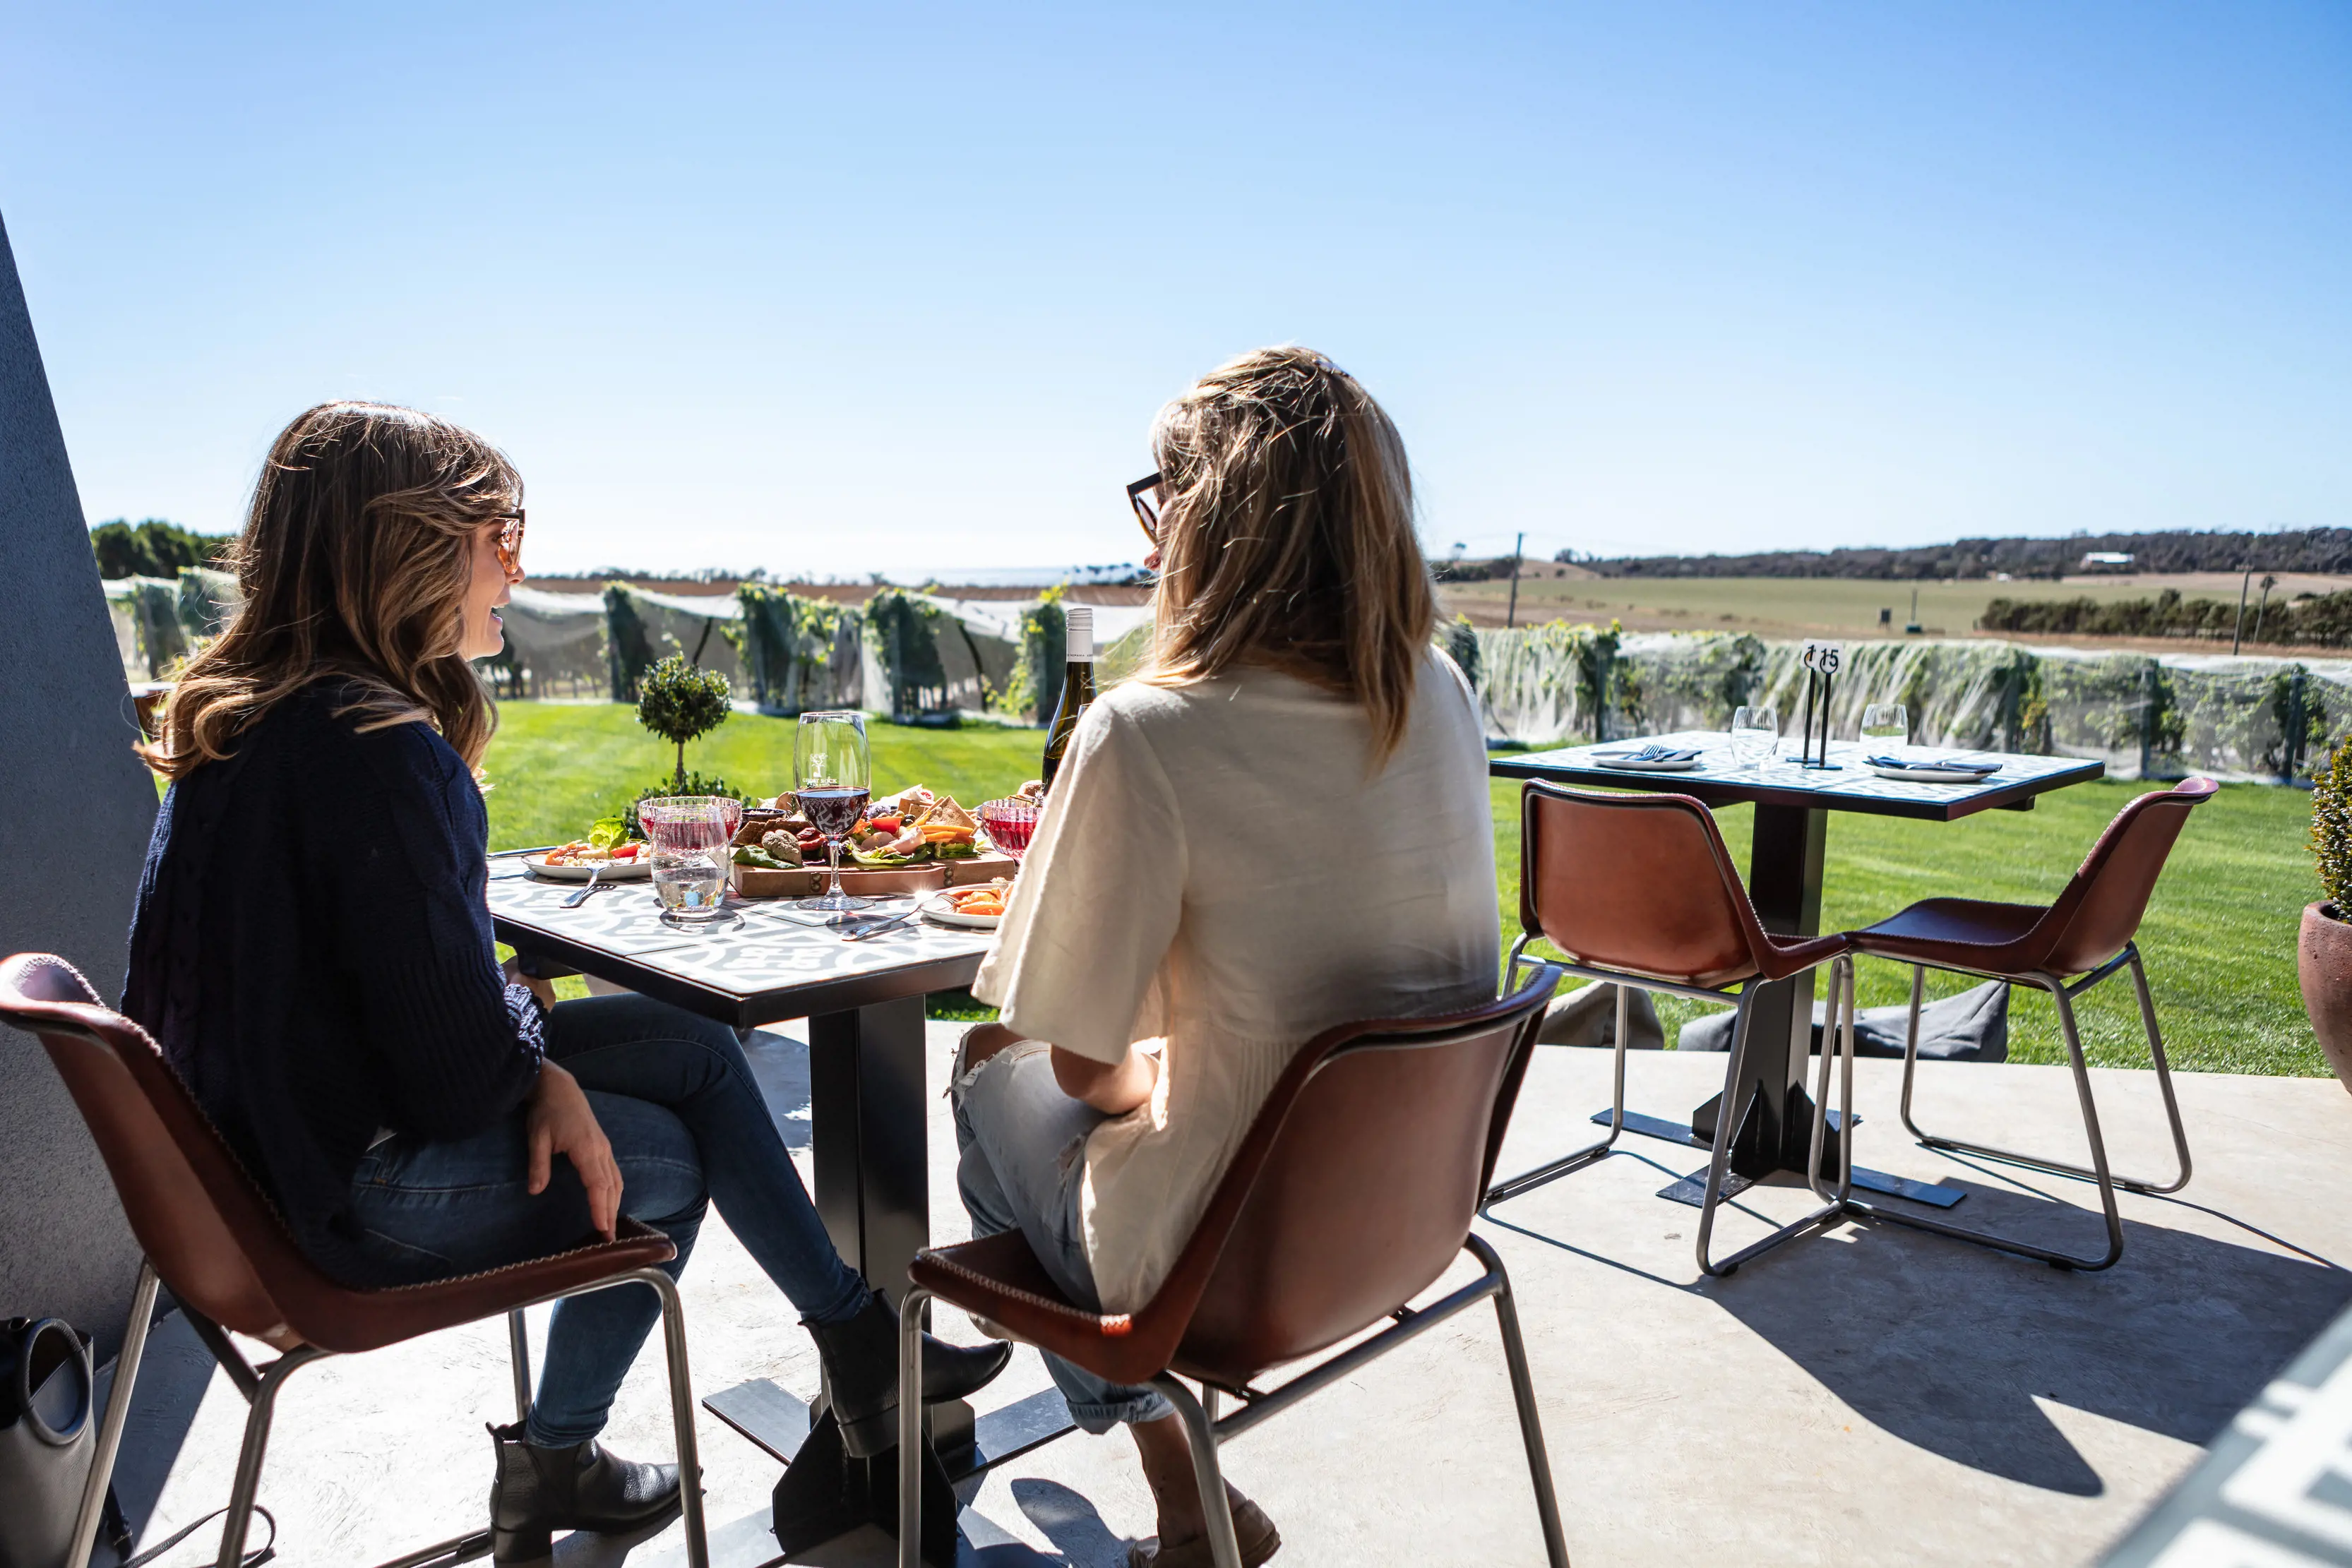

{"left": 122, "top": 402, "right": 1009, "bottom": 1563}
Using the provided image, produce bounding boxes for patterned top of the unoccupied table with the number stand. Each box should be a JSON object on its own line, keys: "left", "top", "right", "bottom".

{"left": 1489, "top": 729, "right": 2108, "bottom": 822}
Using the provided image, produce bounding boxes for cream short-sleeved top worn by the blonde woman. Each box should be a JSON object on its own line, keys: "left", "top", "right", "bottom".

{"left": 972, "top": 649, "right": 1500, "bottom": 1312}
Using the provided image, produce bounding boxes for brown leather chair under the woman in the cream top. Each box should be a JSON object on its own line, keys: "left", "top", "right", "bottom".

{"left": 898, "top": 966, "right": 1569, "bottom": 1568}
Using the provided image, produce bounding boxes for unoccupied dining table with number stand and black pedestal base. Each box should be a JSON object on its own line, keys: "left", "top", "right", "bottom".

{"left": 1486, "top": 731, "right": 2108, "bottom": 1206}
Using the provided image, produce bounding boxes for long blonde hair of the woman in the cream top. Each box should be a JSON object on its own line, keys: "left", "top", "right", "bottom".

{"left": 1150, "top": 348, "right": 1437, "bottom": 762}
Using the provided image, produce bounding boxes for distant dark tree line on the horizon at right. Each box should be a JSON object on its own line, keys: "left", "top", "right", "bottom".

{"left": 1557, "top": 529, "right": 2352, "bottom": 583}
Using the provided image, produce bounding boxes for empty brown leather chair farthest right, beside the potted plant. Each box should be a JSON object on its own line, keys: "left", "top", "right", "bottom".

{"left": 1846, "top": 778, "right": 2220, "bottom": 1269}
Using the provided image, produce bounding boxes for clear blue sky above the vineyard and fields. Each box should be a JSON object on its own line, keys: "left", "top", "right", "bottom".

{"left": 0, "top": 0, "right": 2352, "bottom": 576}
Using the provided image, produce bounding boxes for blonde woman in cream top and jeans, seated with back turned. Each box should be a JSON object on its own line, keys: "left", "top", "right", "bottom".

{"left": 955, "top": 348, "right": 1498, "bottom": 1568}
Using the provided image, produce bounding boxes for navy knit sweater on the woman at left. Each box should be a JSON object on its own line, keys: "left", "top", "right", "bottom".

{"left": 122, "top": 682, "right": 543, "bottom": 1286}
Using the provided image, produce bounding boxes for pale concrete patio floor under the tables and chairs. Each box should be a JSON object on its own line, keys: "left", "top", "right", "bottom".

{"left": 101, "top": 1025, "right": 2352, "bottom": 1568}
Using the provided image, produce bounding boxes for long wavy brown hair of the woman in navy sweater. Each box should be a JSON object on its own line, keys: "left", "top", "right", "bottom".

{"left": 139, "top": 402, "right": 522, "bottom": 778}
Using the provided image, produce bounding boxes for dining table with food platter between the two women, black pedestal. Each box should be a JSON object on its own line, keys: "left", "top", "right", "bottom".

{"left": 487, "top": 851, "right": 1070, "bottom": 1568}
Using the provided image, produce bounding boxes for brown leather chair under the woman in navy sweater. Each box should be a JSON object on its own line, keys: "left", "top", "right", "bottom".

{"left": 0, "top": 952, "right": 710, "bottom": 1568}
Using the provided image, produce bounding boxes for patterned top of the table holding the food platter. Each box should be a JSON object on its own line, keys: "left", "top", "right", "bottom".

{"left": 489, "top": 856, "right": 990, "bottom": 1022}
